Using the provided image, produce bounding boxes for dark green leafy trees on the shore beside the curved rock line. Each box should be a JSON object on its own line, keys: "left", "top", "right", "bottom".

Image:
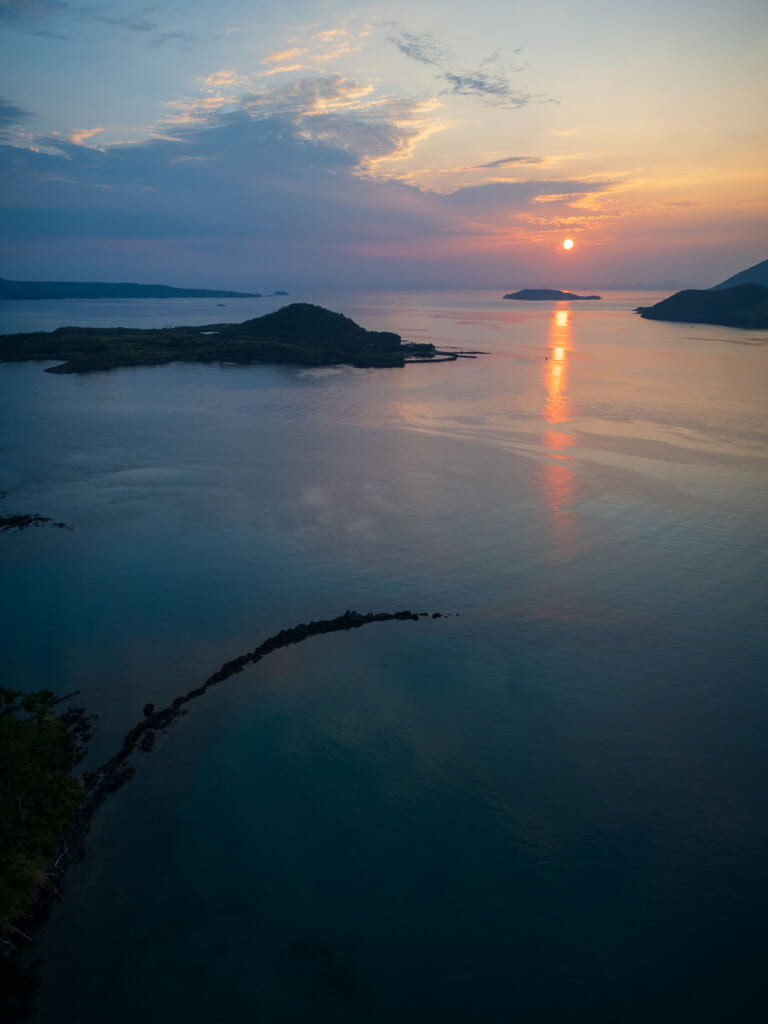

{"left": 0, "top": 686, "right": 84, "bottom": 932}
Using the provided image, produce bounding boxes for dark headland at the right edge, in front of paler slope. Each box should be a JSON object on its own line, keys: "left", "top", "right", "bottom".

{"left": 635, "top": 285, "right": 768, "bottom": 329}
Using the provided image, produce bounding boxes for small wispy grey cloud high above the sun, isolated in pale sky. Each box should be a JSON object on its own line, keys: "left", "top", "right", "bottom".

{"left": 388, "top": 32, "right": 557, "bottom": 108}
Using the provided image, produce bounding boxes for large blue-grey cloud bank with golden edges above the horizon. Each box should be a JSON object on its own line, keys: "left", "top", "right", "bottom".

{"left": 0, "top": 71, "right": 610, "bottom": 290}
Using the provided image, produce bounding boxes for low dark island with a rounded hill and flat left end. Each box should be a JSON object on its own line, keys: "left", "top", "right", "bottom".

{"left": 0, "top": 302, "right": 438, "bottom": 374}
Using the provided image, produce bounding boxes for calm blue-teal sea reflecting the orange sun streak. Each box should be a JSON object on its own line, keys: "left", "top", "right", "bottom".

{"left": 0, "top": 291, "right": 768, "bottom": 1024}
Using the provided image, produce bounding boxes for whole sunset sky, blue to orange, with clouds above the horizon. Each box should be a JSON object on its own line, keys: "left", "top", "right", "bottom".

{"left": 0, "top": 0, "right": 768, "bottom": 292}
